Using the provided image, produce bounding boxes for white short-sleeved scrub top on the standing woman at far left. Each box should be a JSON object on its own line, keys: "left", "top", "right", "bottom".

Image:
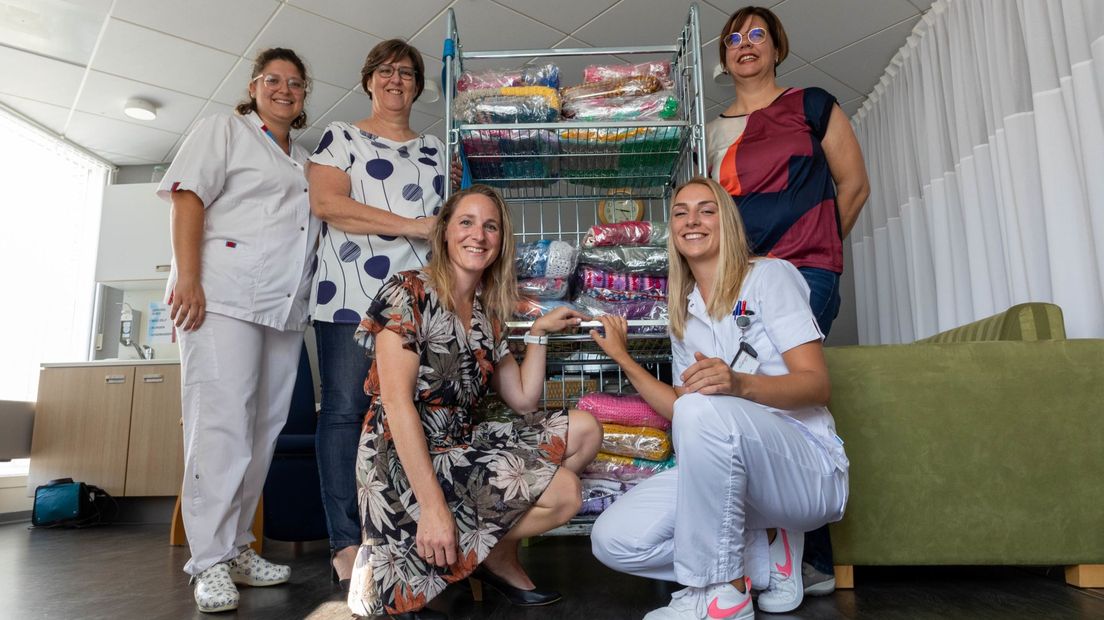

{"left": 157, "top": 114, "right": 320, "bottom": 331}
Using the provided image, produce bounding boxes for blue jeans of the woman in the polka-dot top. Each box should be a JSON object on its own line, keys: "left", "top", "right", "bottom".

{"left": 315, "top": 321, "right": 372, "bottom": 550}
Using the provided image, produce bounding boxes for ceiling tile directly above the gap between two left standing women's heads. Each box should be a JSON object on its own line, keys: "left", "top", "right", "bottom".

{"left": 245, "top": 4, "right": 381, "bottom": 87}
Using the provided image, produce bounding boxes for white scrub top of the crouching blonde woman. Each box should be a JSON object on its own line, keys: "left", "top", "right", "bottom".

{"left": 671, "top": 258, "right": 849, "bottom": 470}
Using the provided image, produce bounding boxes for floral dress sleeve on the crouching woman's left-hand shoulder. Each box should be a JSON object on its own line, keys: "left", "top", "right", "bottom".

{"left": 353, "top": 272, "right": 422, "bottom": 356}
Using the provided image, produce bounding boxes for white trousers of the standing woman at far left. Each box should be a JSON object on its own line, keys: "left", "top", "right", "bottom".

{"left": 180, "top": 313, "right": 302, "bottom": 575}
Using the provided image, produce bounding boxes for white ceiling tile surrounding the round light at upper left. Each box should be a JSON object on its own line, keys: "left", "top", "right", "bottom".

{"left": 76, "top": 71, "right": 205, "bottom": 133}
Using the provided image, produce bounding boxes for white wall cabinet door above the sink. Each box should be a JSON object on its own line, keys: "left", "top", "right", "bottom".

{"left": 96, "top": 183, "right": 172, "bottom": 282}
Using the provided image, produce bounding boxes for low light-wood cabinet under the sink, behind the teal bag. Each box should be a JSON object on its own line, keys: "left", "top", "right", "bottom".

{"left": 28, "top": 364, "right": 183, "bottom": 496}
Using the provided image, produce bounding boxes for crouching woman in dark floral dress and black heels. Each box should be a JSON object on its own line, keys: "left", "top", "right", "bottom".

{"left": 349, "top": 185, "right": 602, "bottom": 618}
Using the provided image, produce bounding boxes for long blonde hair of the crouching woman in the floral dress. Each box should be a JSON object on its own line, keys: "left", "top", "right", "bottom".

{"left": 426, "top": 184, "right": 518, "bottom": 324}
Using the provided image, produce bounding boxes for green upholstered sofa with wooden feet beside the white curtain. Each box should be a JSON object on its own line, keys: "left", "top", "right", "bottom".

{"left": 826, "top": 303, "right": 1104, "bottom": 587}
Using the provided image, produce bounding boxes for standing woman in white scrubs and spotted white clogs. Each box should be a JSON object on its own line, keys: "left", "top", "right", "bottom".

{"left": 158, "top": 47, "right": 319, "bottom": 612}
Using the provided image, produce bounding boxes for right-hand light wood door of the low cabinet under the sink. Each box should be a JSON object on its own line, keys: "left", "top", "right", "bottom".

{"left": 126, "top": 364, "right": 184, "bottom": 495}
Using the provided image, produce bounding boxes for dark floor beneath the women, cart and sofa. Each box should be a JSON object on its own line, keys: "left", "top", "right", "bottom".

{"left": 0, "top": 524, "right": 1104, "bottom": 620}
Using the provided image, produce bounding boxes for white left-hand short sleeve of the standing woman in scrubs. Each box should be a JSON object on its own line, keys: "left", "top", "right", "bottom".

{"left": 157, "top": 115, "right": 234, "bottom": 207}
